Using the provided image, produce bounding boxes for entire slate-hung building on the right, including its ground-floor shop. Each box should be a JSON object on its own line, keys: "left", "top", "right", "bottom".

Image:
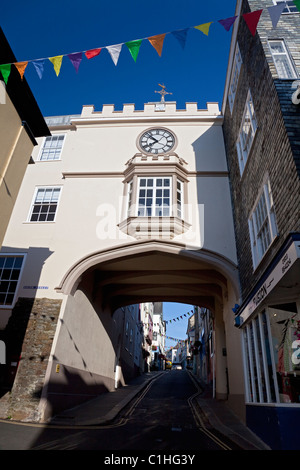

{"left": 222, "top": 0, "right": 300, "bottom": 449}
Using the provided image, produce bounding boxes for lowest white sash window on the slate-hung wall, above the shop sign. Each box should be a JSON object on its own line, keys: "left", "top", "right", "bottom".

{"left": 248, "top": 179, "right": 278, "bottom": 270}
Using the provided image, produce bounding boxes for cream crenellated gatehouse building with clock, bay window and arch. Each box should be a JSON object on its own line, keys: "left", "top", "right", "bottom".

{"left": 1, "top": 102, "right": 244, "bottom": 421}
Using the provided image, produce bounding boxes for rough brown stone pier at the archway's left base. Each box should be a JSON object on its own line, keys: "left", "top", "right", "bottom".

{"left": 0, "top": 298, "right": 61, "bottom": 422}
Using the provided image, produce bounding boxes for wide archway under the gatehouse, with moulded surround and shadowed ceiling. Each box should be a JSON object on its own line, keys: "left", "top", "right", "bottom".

{"left": 35, "top": 240, "right": 238, "bottom": 419}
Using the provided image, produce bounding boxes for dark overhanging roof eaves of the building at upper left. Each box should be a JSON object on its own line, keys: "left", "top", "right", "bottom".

{"left": 0, "top": 28, "right": 51, "bottom": 137}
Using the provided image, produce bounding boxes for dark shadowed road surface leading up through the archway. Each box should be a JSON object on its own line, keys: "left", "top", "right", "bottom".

{"left": 0, "top": 370, "right": 244, "bottom": 454}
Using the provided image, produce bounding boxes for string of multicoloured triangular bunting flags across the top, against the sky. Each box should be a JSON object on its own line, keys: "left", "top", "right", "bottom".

{"left": 0, "top": 0, "right": 300, "bottom": 84}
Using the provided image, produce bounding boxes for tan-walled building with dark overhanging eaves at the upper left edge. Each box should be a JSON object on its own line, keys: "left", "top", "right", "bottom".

{"left": 0, "top": 28, "right": 50, "bottom": 246}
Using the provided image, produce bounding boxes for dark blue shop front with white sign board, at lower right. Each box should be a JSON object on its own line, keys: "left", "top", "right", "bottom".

{"left": 235, "top": 234, "right": 300, "bottom": 450}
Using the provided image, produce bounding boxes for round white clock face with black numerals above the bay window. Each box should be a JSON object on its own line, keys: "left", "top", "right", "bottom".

{"left": 139, "top": 129, "right": 175, "bottom": 155}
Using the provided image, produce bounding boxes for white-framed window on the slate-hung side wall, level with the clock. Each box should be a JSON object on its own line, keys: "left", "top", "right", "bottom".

{"left": 236, "top": 90, "right": 257, "bottom": 175}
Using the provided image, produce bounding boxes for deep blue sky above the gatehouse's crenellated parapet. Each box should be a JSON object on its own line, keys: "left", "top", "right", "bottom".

{"left": 0, "top": 0, "right": 236, "bottom": 116}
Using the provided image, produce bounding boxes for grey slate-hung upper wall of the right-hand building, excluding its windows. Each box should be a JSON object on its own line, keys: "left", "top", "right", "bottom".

{"left": 224, "top": 0, "right": 300, "bottom": 299}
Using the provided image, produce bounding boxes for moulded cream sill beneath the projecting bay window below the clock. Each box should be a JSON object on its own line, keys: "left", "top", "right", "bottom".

{"left": 118, "top": 217, "right": 191, "bottom": 240}
